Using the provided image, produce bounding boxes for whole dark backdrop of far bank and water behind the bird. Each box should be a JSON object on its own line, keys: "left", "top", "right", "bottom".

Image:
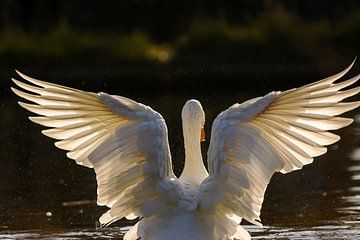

{"left": 0, "top": 0, "right": 360, "bottom": 230}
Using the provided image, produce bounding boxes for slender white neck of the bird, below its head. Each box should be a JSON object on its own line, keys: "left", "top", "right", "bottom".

{"left": 180, "top": 122, "right": 208, "bottom": 184}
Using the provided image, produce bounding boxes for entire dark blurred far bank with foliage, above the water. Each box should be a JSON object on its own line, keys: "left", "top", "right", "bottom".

{"left": 0, "top": 0, "right": 360, "bottom": 88}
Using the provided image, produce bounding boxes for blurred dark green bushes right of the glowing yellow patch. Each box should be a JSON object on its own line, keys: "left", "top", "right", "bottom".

{"left": 175, "top": 7, "right": 360, "bottom": 68}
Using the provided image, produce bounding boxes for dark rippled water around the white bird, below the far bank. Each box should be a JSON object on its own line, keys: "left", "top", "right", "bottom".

{"left": 0, "top": 72, "right": 360, "bottom": 240}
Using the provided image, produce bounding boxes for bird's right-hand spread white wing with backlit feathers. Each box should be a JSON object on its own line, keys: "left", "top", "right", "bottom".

{"left": 200, "top": 59, "right": 360, "bottom": 227}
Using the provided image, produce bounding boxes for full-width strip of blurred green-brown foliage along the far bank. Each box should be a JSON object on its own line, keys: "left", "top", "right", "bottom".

{"left": 0, "top": 4, "right": 360, "bottom": 69}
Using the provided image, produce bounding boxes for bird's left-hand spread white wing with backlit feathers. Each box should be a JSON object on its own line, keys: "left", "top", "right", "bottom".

{"left": 12, "top": 72, "right": 178, "bottom": 226}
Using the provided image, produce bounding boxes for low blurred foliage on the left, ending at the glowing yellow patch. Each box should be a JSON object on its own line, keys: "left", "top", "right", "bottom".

{"left": 0, "top": 21, "right": 173, "bottom": 62}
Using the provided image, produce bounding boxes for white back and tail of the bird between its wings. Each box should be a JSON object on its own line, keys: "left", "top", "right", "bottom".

{"left": 124, "top": 181, "right": 250, "bottom": 240}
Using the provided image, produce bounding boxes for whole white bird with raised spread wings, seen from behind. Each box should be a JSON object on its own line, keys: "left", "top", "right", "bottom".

{"left": 12, "top": 60, "right": 360, "bottom": 240}
